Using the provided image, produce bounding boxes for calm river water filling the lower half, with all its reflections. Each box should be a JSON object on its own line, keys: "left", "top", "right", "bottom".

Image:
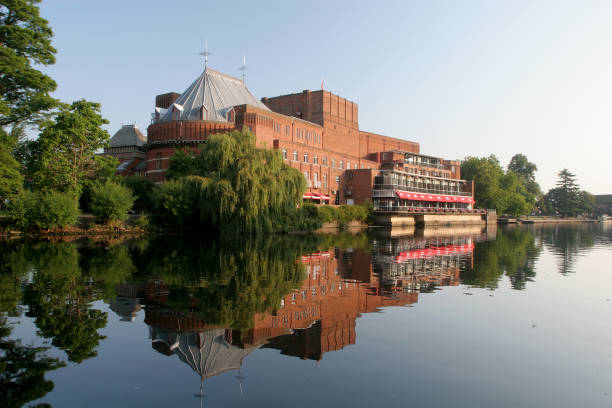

{"left": 0, "top": 224, "right": 612, "bottom": 407}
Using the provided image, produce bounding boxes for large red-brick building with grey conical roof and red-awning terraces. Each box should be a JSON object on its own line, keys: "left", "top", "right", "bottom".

{"left": 107, "top": 63, "right": 473, "bottom": 210}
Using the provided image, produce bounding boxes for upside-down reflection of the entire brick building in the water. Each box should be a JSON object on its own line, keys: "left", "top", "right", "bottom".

{"left": 109, "top": 237, "right": 482, "bottom": 379}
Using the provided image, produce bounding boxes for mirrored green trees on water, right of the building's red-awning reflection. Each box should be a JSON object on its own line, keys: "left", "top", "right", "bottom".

{"left": 461, "top": 228, "right": 541, "bottom": 290}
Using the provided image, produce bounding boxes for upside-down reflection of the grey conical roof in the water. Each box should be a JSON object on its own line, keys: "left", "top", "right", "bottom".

{"left": 150, "top": 326, "right": 257, "bottom": 378}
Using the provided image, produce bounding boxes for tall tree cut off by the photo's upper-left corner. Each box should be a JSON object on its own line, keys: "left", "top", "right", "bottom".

{"left": 0, "top": 0, "right": 58, "bottom": 127}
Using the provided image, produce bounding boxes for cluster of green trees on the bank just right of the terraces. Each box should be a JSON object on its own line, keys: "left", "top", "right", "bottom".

{"left": 461, "top": 155, "right": 535, "bottom": 216}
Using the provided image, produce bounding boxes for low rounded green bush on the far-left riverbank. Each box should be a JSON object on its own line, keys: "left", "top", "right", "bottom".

{"left": 8, "top": 191, "right": 79, "bottom": 230}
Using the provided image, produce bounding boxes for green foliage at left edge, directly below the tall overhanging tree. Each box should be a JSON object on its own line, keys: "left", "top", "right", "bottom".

{"left": 0, "top": 128, "right": 23, "bottom": 204}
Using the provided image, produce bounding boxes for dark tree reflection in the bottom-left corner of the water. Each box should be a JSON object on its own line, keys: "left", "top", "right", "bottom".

{"left": 0, "top": 319, "right": 65, "bottom": 408}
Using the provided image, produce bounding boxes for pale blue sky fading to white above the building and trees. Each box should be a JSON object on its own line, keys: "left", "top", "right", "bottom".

{"left": 40, "top": 0, "right": 612, "bottom": 194}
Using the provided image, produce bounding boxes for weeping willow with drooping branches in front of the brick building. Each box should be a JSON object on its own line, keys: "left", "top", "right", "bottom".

{"left": 157, "top": 130, "right": 306, "bottom": 233}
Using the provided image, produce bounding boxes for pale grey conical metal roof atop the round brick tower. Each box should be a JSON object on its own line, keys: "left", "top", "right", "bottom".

{"left": 159, "top": 67, "right": 270, "bottom": 122}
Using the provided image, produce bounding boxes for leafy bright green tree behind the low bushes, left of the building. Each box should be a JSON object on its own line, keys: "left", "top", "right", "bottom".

{"left": 28, "top": 100, "right": 117, "bottom": 194}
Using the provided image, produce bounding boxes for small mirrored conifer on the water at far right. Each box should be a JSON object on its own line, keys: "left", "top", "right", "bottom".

{"left": 538, "top": 224, "right": 596, "bottom": 274}
